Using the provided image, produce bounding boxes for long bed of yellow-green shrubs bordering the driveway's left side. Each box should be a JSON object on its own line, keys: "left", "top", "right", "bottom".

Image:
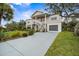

{"left": 0, "top": 29, "right": 34, "bottom": 42}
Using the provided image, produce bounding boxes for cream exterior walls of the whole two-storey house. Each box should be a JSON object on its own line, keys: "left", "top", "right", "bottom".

{"left": 26, "top": 12, "right": 62, "bottom": 32}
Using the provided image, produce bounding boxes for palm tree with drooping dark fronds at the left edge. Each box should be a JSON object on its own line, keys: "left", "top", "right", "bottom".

{"left": 0, "top": 3, "right": 13, "bottom": 26}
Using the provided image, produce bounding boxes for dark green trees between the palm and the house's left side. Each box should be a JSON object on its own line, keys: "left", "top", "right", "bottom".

{"left": 6, "top": 20, "right": 26, "bottom": 31}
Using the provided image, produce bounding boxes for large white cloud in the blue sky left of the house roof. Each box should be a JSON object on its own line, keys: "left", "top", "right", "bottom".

{"left": 13, "top": 10, "right": 34, "bottom": 22}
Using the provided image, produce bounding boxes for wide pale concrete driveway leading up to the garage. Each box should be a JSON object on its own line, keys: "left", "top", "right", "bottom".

{"left": 0, "top": 32, "right": 58, "bottom": 56}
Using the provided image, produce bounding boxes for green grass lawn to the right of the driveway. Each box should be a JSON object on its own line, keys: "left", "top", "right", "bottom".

{"left": 45, "top": 32, "right": 79, "bottom": 56}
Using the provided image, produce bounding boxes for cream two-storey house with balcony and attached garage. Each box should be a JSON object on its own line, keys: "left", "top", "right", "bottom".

{"left": 26, "top": 11, "right": 62, "bottom": 32}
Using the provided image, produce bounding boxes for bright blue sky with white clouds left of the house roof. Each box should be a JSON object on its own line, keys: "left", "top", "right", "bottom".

{"left": 2, "top": 3, "right": 45, "bottom": 25}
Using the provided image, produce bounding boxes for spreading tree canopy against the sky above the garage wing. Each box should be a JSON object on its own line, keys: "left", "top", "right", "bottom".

{"left": 46, "top": 3, "right": 79, "bottom": 17}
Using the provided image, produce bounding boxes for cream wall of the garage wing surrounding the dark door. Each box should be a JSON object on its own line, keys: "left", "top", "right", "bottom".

{"left": 46, "top": 15, "right": 62, "bottom": 32}
